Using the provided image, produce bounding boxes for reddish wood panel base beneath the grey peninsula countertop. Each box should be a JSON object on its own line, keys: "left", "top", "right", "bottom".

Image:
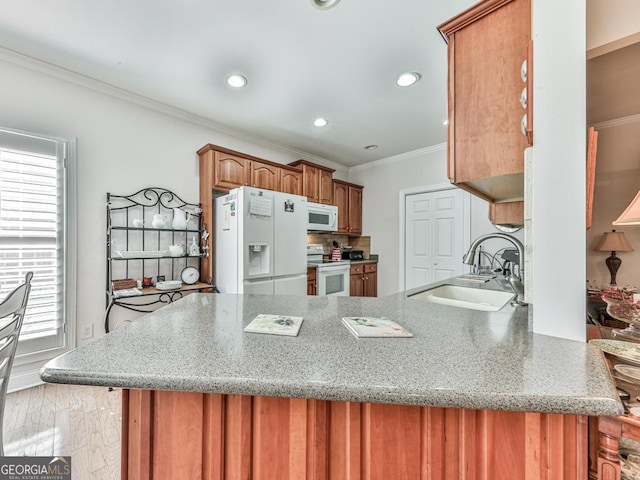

{"left": 122, "top": 389, "right": 588, "bottom": 480}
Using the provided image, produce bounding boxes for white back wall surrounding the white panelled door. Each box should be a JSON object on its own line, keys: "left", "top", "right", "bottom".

{"left": 349, "top": 145, "right": 522, "bottom": 296}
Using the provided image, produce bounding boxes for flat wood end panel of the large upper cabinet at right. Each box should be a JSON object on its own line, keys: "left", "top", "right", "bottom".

{"left": 449, "top": 0, "right": 531, "bottom": 182}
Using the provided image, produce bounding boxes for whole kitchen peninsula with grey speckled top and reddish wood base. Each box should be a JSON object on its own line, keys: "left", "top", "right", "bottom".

{"left": 41, "top": 280, "right": 622, "bottom": 480}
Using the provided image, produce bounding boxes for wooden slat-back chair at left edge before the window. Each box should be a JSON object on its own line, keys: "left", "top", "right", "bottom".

{"left": 0, "top": 272, "right": 33, "bottom": 456}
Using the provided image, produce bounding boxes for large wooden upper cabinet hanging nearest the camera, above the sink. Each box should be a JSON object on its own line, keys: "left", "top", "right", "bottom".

{"left": 438, "top": 0, "right": 533, "bottom": 227}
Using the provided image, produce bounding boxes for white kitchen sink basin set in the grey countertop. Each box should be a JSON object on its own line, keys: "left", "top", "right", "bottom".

{"left": 409, "top": 285, "right": 515, "bottom": 312}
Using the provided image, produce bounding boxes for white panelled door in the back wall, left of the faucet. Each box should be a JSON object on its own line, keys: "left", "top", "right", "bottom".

{"left": 404, "top": 188, "right": 468, "bottom": 290}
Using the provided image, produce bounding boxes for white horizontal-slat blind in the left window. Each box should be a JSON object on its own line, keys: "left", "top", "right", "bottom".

{"left": 0, "top": 131, "right": 65, "bottom": 344}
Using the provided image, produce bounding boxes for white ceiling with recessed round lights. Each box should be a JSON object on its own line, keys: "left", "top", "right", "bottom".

{"left": 0, "top": 0, "right": 475, "bottom": 166}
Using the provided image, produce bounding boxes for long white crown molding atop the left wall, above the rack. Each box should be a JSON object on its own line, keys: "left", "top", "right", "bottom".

{"left": 0, "top": 47, "right": 347, "bottom": 170}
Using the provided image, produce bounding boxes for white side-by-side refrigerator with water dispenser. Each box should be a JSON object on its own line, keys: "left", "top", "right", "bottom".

{"left": 213, "top": 187, "right": 308, "bottom": 295}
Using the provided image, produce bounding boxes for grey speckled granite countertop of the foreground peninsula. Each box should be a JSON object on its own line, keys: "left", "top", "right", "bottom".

{"left": 40, "top": 282, "right": 623, "bottom": 415}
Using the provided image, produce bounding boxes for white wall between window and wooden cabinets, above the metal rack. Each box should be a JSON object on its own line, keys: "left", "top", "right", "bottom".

{"left": 0, "top": 54, "right": 346, "bottom": 343}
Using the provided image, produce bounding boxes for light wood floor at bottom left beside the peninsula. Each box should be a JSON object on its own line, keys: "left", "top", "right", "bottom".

{"left": 4, "top": 384, "right": 122, "bottom": 480}
